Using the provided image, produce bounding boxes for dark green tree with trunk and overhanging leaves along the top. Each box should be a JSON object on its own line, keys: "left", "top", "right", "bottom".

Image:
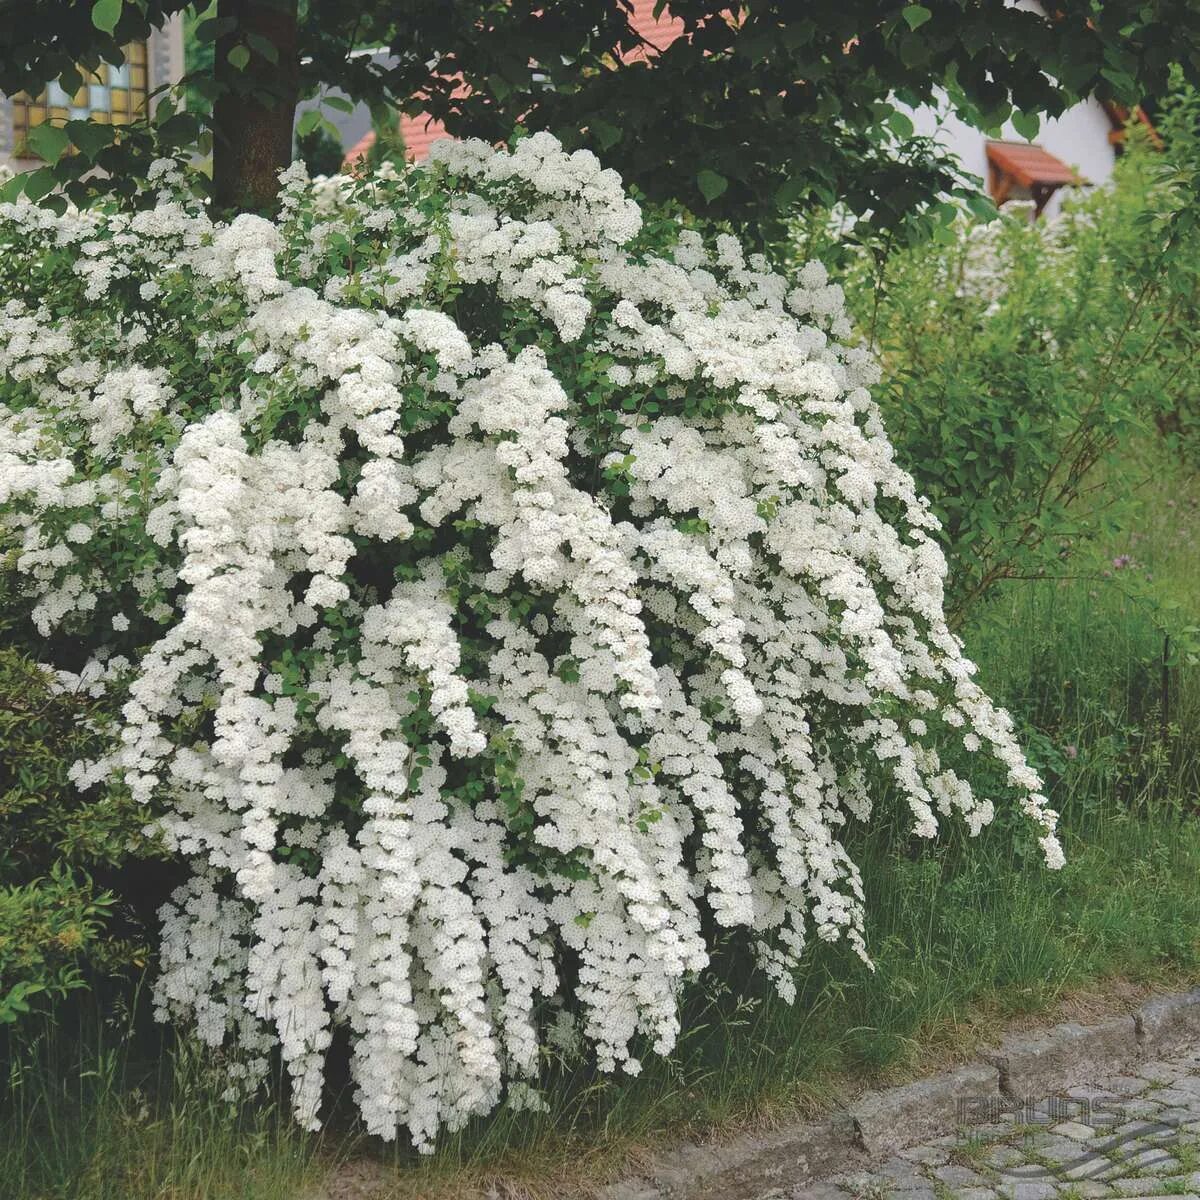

{"left": 0, "top": 0, "right": 1200, "bottom": 227}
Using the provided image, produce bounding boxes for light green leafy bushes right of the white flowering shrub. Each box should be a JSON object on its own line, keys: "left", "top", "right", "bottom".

{"left": 835, "top": 109, "right": 1200, "bottom": 616}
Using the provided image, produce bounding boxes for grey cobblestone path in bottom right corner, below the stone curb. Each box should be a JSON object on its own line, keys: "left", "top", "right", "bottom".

{"left": 801, "top": 1044, "right": 1200, "bottom": 1200}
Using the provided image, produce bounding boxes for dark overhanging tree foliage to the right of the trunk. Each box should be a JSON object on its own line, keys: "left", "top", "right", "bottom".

{"left": 376, "top": 0, "right": 1200, "bottom": 240}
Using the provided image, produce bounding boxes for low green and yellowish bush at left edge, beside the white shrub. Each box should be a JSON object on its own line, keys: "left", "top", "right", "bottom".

{"left": 0, "top": 623, "right": 159, "bottom": 1025}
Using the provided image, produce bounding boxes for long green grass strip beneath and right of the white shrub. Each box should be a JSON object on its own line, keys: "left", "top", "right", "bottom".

{"left": 7, "top": 463, "right": 1200, "bottom": 1200}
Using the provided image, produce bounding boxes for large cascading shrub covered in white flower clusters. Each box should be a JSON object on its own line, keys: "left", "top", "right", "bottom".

{"left": 0, "top": 134, "right": 1061, "bottom": 1147}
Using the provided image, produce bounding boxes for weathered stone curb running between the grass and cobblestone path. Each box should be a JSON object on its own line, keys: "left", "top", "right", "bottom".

{"left": 596, "top": 989, "right": 1200, "bottom": 1200}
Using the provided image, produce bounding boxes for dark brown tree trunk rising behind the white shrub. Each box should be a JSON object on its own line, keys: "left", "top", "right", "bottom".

{"left": 212, "top": 0, "right": 300, "bottom": 214}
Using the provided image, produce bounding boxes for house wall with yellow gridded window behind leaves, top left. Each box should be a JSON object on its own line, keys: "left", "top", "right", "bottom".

{"left": 0, "top": 13, "right": 184, "bottom": 170}
